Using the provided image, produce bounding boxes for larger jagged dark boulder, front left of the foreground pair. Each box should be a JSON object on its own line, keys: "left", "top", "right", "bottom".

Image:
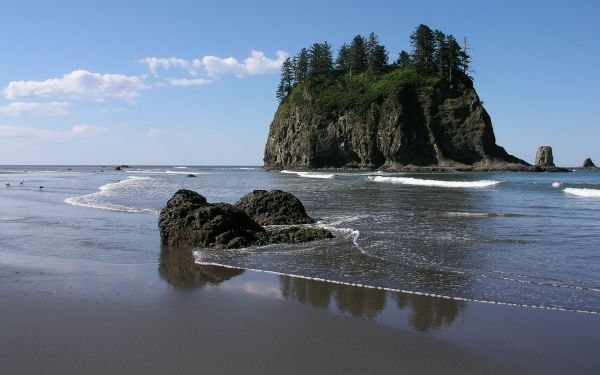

{"left": 158, "top": 189, "right": 265, "bottom": 249}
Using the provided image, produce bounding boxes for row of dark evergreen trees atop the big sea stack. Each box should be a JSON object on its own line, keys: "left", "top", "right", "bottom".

{"left": 276, "top": 25, "right": 472, "bottom": 102}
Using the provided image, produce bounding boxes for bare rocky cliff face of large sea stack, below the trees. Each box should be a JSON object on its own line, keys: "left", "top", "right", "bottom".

{"left": 264, "top": 73, "right": 527, "bottom": 169}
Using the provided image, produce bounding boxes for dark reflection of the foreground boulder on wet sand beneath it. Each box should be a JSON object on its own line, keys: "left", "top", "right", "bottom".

{"left": 158, "top": 246, "right": 244, "bottom": 289}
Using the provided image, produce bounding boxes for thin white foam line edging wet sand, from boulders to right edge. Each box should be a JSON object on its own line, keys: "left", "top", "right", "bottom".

{"left": 195, "top": 262, "right": 600, "bottom": 315}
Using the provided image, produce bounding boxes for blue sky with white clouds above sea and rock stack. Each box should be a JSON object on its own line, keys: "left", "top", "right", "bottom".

{"left": 0, "top": 0, "right": 600, "bottom": 166}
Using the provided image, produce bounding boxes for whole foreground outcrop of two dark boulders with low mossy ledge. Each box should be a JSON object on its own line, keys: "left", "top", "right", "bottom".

{"left": 158, "top": 189, "right": 333, "bottom": 249}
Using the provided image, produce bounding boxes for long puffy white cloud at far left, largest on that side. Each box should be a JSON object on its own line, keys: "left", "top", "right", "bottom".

{"left": 4, "top": 70, "right": 149, "bottom": 101}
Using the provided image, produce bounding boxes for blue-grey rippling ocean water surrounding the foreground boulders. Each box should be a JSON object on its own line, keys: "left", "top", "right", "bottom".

{"left": 0, "top": 166, "right": 600, "bottom": 314}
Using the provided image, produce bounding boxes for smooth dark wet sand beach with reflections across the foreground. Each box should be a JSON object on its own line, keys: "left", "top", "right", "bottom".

{"left": 0, "top": 253, "right": 600, "bottom": 374}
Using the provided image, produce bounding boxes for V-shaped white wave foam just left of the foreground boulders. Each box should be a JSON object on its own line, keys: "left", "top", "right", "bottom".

{"left": 64, "top": 176, "right": 160, "bottom": 215}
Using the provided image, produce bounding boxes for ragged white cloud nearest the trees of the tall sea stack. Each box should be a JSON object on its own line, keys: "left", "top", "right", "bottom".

{"left": 140, "top": 50, "right": 289, "bottom": 80}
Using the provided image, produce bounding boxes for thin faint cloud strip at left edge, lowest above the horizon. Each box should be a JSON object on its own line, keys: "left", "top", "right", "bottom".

{"left": 0, "top": 124, "right": 106, "bottom": 141}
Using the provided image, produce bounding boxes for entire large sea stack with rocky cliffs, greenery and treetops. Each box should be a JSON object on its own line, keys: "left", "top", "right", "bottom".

{"left": 264, "top": 25, "right": 526, "bottom": 169}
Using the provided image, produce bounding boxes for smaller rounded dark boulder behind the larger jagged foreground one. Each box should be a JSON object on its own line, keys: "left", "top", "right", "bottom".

{"left": 235, "top": 190, "right": 314, "bottom": 225}
